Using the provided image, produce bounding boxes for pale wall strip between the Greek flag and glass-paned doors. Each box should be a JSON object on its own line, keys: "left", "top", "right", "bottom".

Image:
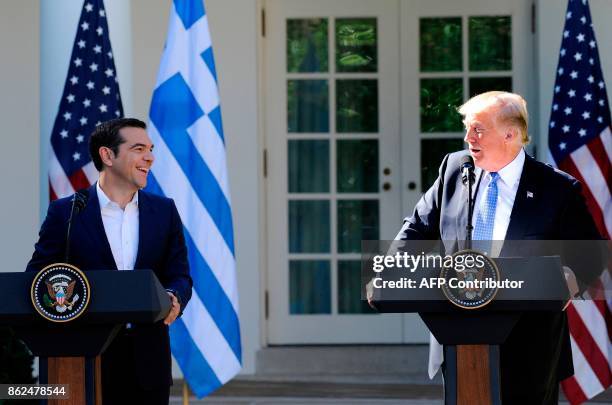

{"left": 206, "top": 0, "right": 265, "bottom": 373}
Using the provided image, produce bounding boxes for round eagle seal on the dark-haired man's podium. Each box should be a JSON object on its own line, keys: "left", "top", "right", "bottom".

{"left": 30, "top": 263, "right": 91, "bottom": 322}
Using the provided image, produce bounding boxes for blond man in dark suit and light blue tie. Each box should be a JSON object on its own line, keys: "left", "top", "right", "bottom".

{"left": 396, "top": 91, "right": 600, "bottom": 405}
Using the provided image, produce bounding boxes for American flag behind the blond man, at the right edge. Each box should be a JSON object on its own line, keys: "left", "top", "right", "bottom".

{"left": 548, "top": 0, "right": 612, "bottom": 405}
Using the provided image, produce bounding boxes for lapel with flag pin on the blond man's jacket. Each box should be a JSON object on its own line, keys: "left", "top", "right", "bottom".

{"left": 506, "top": 154, "right": 537, "bottom": 240}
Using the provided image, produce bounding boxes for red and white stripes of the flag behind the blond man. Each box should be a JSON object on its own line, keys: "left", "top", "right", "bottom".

{"left": 559, "top": 127, "right": 612, "bottom": 405}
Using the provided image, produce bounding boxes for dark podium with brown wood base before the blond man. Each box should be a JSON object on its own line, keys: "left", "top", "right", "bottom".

{"left": 374, "top": 256, "right": 569, "bottom": 405}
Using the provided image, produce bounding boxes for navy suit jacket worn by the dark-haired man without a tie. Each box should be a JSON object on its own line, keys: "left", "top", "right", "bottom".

{"left": 27, "top": 184, "right": 192, "bottom": 388}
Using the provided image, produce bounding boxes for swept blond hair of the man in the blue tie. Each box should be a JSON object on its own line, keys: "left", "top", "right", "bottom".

{"left": 458, "top": 91, "right": 530, "bottom": 145}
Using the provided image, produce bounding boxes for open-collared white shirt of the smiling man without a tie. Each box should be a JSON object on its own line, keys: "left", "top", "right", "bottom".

{"left": 96, "top": 182, "right": 140, "bottom": 270}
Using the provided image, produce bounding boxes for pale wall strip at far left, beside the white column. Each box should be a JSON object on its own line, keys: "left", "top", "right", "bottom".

{"left": 0, "top": 0, "right": 40, "bottom": 271}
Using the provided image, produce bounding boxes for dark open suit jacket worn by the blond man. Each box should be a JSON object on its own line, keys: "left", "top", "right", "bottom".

{"left": 396, "top": 151, "right": 601, "bottom": 393}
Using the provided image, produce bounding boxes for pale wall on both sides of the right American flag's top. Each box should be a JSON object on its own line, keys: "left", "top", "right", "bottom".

{"left": 536, "top": 0, "right": 612, "bottom": 160}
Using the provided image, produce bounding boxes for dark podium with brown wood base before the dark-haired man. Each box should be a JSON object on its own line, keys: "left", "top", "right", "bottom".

{"left": 0, "top": 270, "right": 171, "bottom": 405}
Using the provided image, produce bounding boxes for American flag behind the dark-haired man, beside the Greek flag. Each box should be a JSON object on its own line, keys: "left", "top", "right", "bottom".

{"left": 49, "top": 0, "right": 123, "bottom": 200}
